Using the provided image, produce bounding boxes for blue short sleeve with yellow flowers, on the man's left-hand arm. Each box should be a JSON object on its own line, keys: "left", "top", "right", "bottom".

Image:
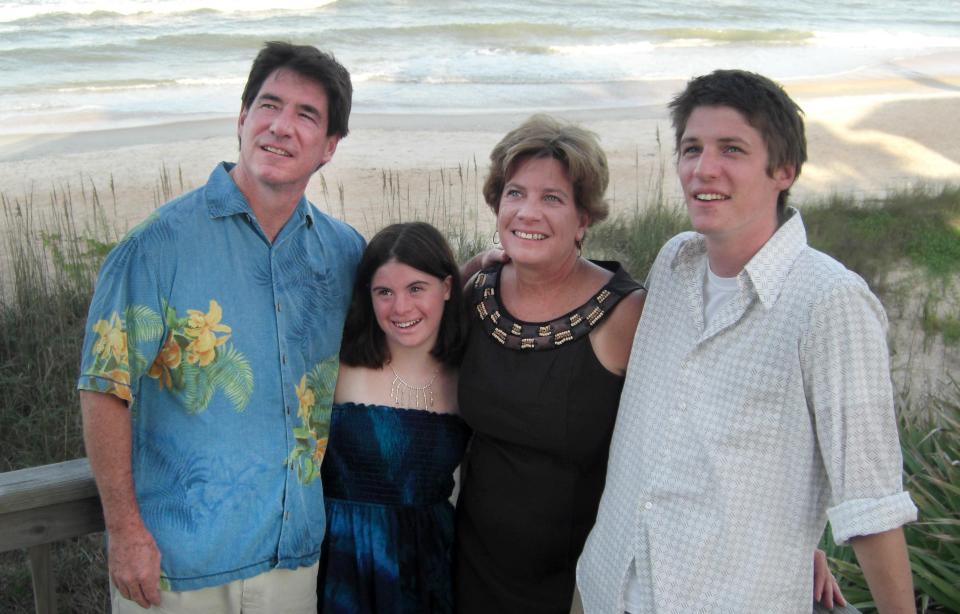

{"left": 77, "top": 231, "right": 166, "bottom": 405}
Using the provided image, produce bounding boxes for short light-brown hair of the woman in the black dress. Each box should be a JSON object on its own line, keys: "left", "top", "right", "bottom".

{"left": 483, "top": 114, "right": 610, "bottom": 225}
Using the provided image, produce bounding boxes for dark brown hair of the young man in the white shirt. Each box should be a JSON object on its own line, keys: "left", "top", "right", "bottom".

{"left": 669, "top": 70, "right": 807, "bottom": 219}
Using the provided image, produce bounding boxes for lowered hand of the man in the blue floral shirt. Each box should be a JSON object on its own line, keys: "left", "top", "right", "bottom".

{"left": 107, "top": 527, "right": 160, "bottom": 608}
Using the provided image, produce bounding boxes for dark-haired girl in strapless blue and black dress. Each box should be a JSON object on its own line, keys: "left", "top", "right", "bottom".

{"left": 317, "top": 223, "right": 469, "bottom": 614}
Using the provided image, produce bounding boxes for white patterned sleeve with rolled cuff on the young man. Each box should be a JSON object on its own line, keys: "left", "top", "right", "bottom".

{"left": 801, "top": 274, "right": 917, "bottom": 543}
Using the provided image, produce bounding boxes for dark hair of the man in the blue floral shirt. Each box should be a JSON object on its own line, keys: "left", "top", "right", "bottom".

{"left": 242, "top": 41, "right": 353, "bottom": 138}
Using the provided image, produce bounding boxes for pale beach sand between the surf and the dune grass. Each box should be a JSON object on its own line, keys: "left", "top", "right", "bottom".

{"left": 0, "top": 70, "right": 960, "bottom": 236}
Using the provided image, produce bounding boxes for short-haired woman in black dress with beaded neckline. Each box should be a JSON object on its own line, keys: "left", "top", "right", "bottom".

{"left": 456, "top": 115, "right": 645, "bottom": 613}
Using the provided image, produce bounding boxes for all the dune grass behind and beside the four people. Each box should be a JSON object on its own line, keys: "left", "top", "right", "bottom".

{"left": 0, "top": 166, "right": 960, "bottom": 612}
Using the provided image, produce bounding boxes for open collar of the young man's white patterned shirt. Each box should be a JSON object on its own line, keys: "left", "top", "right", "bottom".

{"left": 673, "top": 207, "right": 807, "bottom": 309}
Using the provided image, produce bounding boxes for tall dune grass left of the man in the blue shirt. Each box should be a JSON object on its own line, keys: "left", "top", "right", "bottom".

{"left": 0, "top": 188, "right": 117, "bottom": 613}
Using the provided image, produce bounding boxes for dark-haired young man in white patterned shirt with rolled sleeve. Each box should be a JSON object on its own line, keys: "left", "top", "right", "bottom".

{"left": 578, "top": 71, "right": 916, "bottom": 614}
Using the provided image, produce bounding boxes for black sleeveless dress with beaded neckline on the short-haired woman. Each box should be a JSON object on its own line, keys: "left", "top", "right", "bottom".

{"left": 454, "top": 262, "right": 641, "bottom": 614}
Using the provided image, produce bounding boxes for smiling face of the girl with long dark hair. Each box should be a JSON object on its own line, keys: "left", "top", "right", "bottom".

{"left": 370, "top": 260, "right": 452, "bottom": 350}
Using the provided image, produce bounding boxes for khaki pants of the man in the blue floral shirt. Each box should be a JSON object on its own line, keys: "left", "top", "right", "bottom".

{"left": 110, "top": 563, "right": 319, "bottom": 614}
